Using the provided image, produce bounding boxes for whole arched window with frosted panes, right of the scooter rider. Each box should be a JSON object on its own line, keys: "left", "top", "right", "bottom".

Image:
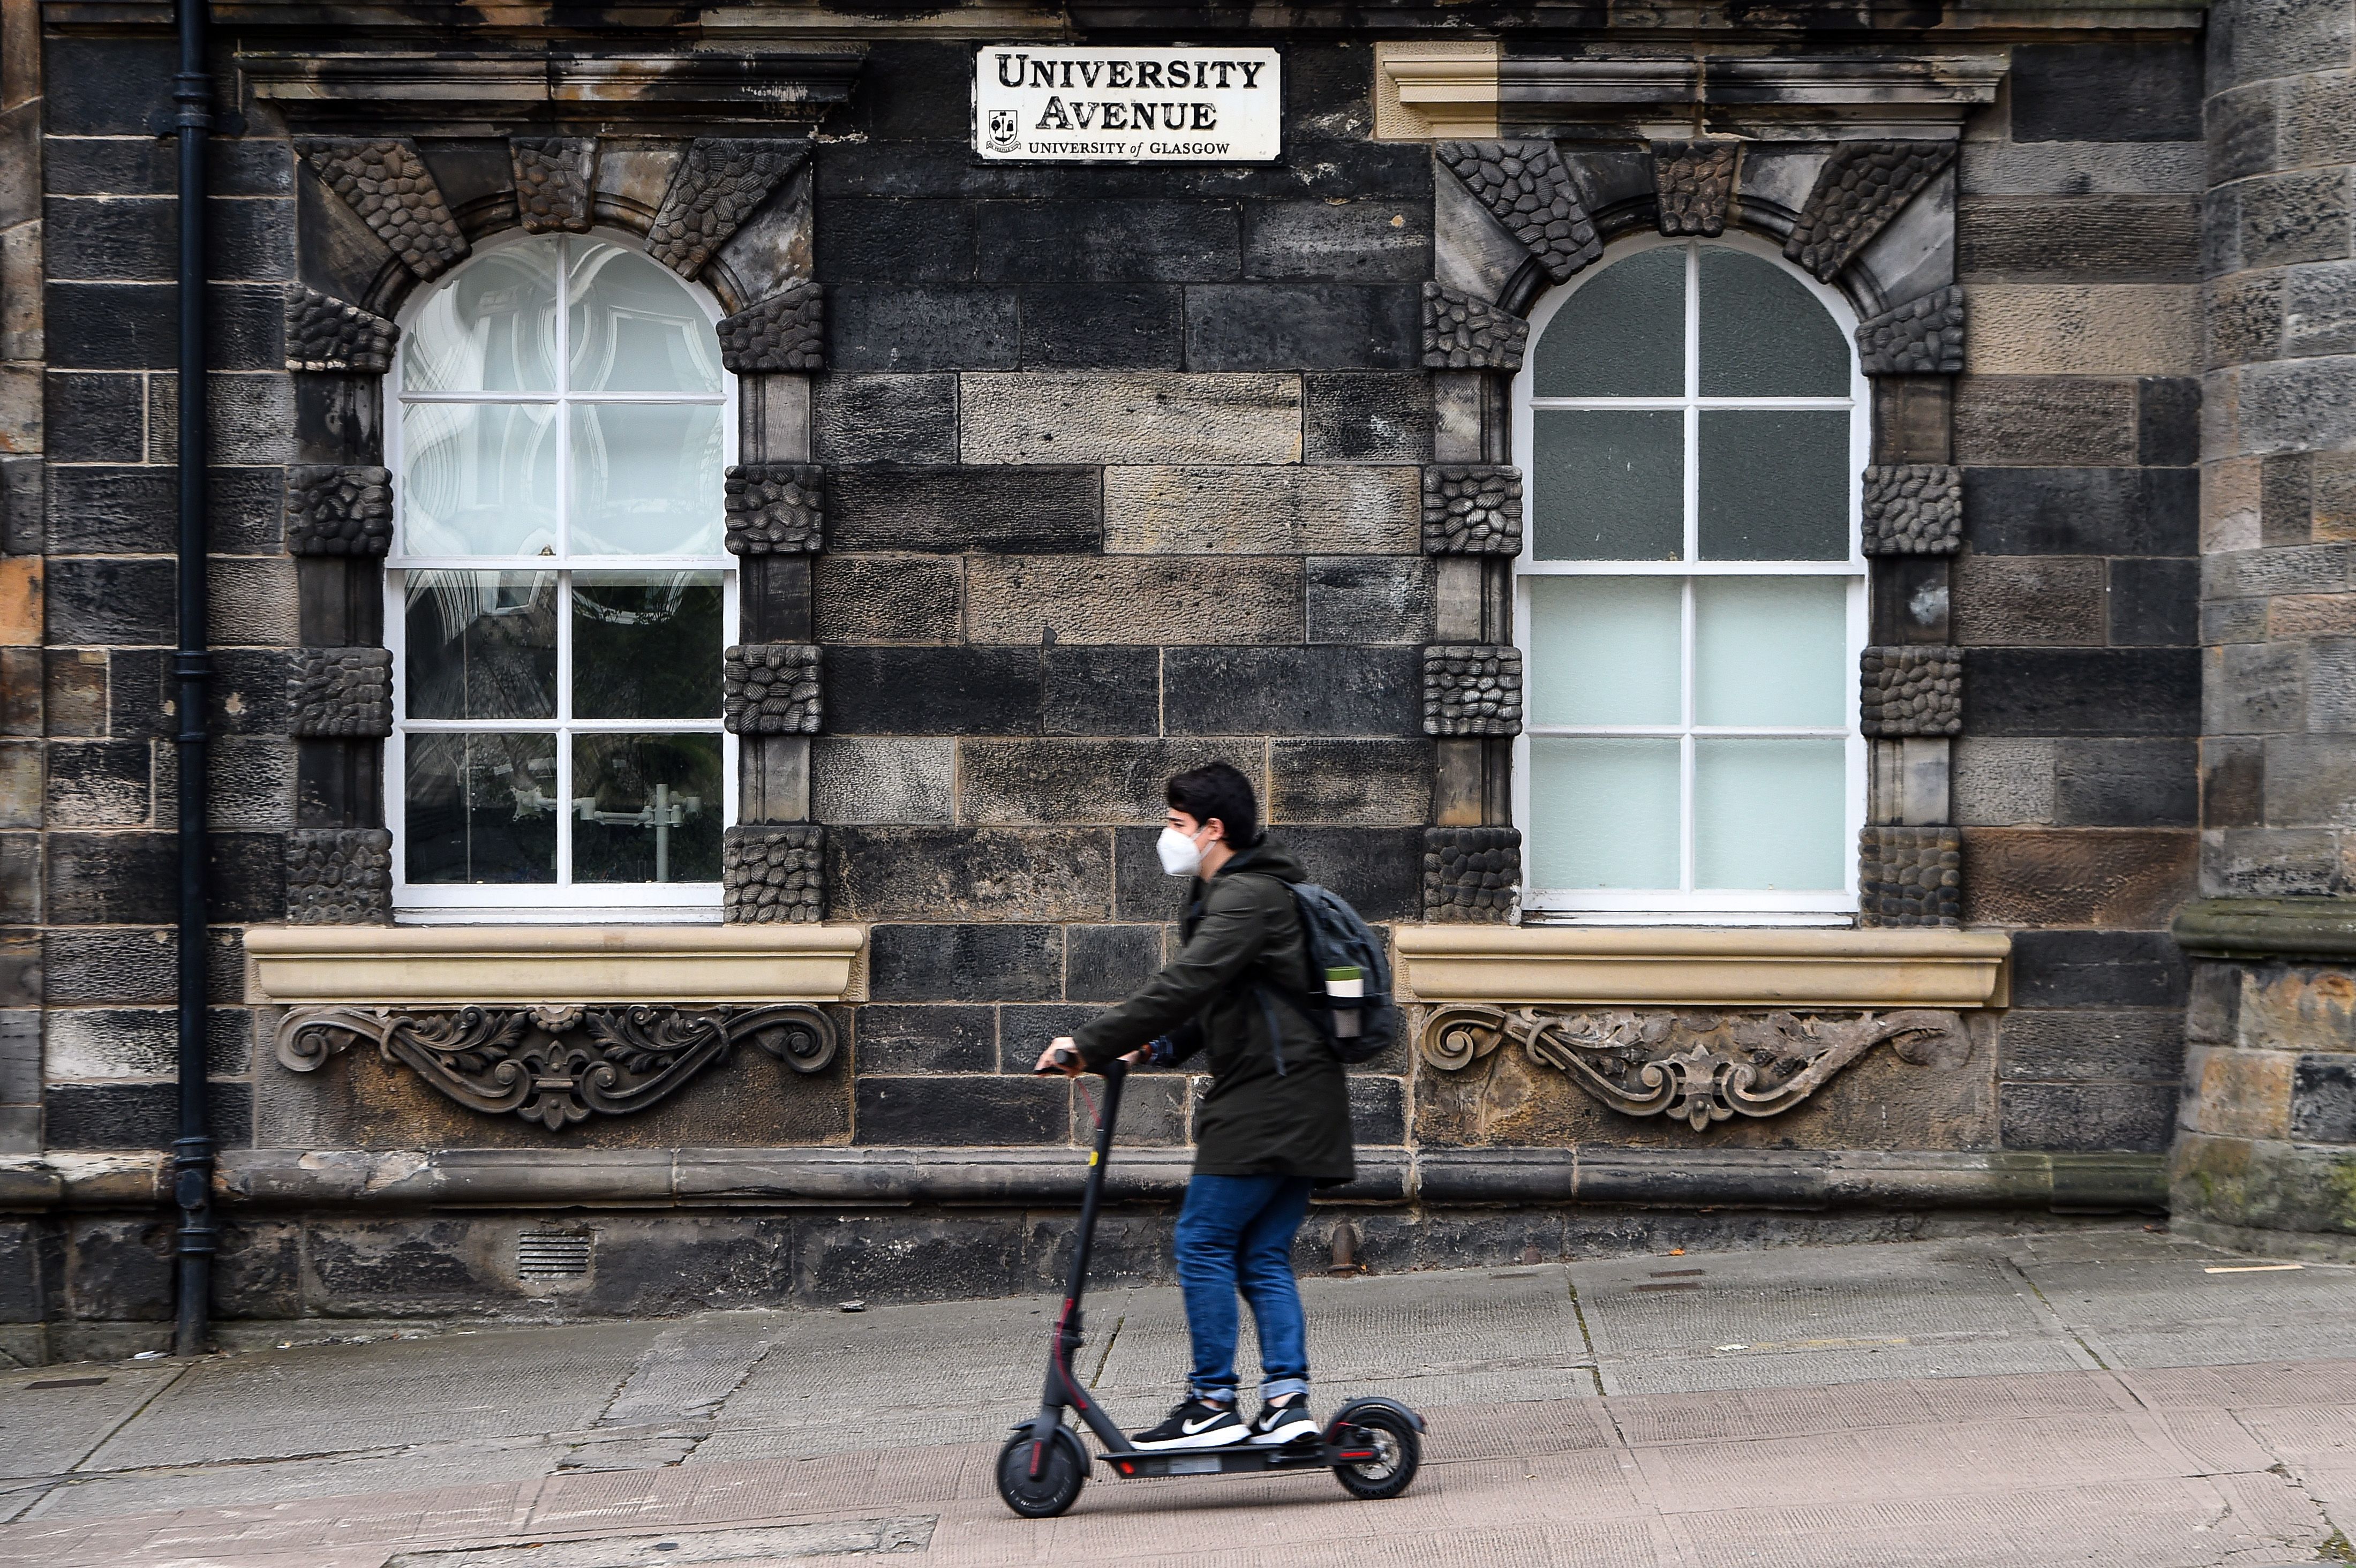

{"left": 1515, "top": 236, "right": 1868, "bottom": 923}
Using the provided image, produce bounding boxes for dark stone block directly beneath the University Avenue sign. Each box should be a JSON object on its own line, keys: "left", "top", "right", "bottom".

{"left": 978, "top": 200, "right": 1241, "bottom": 281}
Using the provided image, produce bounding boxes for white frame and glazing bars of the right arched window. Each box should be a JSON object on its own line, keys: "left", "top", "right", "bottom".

{"left": 1512, "top": 231, "right": 1873, "bottom": 925}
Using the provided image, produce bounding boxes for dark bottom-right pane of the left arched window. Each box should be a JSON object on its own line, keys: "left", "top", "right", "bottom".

{"left": 573, "top": 735, "right": 726, "bottom": 883}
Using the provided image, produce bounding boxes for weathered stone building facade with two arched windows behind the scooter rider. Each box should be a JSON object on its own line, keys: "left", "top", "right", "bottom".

{"left": 0, "top": 0, "right": 2356, "bottom": 1361}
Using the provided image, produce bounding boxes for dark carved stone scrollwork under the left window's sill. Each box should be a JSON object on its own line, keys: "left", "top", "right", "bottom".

{"left": 278, "top": 1003, "right": 841, "bottom": 1133}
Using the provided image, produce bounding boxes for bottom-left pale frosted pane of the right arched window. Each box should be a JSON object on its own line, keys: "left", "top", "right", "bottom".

{"left": 1529, "top": 735, "right": 1677, "bottom": 892}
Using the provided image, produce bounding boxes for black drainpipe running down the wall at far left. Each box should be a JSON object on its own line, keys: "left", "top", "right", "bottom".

{"left": 172, "top": 0, "right": 212, "bottom": 1356}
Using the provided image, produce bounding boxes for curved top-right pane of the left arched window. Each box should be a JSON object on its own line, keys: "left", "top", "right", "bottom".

{"left": 566, "top": 240, "right": 721, "bottom": 393}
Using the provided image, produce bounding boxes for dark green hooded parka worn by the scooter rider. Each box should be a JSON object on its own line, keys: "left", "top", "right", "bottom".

{"left": 1072, "top": 838, "right": 1357, "bottom": 1187}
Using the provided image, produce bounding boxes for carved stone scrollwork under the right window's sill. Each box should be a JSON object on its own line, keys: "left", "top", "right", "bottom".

{"left": 1418, "top": 1003, "right": 1972, "bottom": 1130}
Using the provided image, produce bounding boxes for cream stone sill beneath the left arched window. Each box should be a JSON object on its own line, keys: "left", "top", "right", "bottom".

{"left": 245, "top": 925, "right": 867, "bottom": 1005}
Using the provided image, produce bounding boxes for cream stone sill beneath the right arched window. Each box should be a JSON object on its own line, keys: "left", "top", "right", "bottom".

{"left": 1392, "top": 925, "right": 2012, "bottom": 1008}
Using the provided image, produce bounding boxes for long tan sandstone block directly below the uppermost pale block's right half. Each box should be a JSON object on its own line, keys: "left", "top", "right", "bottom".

{"left": 1105, "top": 464, "right": 1423, "bottom": 556}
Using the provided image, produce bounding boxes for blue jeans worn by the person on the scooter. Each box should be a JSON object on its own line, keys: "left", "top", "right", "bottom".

{"left": 1178, "top": 1175, "right": 1310, "bottom": 1401}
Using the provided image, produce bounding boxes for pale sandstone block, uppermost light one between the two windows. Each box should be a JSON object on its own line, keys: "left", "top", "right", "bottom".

{"left": 959, "top": 372, "right": 1300, "bottom": 464}
